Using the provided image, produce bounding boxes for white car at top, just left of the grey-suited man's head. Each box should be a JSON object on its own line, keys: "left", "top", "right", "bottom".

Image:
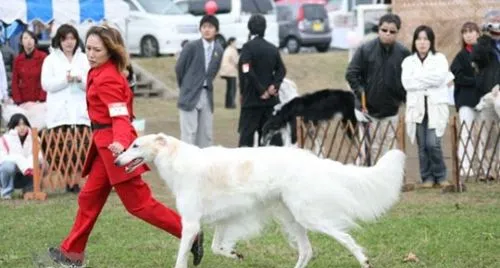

{"left": 124, "top": 0, "right": 200, "bottom": 57}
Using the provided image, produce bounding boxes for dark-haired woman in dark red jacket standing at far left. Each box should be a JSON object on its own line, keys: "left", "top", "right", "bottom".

{"left": 12, "top": 30, "right": 47, "bottom": 105}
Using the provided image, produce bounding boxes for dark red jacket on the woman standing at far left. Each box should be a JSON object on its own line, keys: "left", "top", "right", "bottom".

{"left": 12, "top": 49, "right": 47, "bottom": 104}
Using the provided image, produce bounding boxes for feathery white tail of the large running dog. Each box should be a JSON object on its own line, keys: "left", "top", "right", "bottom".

{"left": 346, "top": 150, "right": 406, "bottom": 221}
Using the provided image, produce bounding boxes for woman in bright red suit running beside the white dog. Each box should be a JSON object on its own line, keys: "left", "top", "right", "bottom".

{"left": 49, "top": 26, "right": 203, "bottom": 267}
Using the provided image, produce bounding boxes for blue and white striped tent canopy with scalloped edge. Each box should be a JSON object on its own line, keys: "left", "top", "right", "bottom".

{"left": 0, "top": 0, "right": 129, "bottom": 24}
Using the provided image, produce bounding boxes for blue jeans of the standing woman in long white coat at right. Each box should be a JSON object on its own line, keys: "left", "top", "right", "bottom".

{"left": 417, "top": 114, "right": 446, "bottom": 183}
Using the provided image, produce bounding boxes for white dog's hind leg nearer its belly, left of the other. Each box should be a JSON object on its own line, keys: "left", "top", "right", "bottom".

{"left": 272, "top": 205, "right": 313, "bottom": 268}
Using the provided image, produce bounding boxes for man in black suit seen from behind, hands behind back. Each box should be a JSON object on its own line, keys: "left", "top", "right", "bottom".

{"left": 238, "top": 14, "right": 286, "bottom": 147}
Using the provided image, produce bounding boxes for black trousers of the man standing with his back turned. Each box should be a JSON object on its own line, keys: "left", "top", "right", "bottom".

{"left": 238, "top": 106, "right": 283, "bottom": 147}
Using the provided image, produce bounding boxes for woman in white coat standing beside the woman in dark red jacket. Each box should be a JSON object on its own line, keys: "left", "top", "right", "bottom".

{"left": 42, "top": 24, "right": 90, "bottom": 193}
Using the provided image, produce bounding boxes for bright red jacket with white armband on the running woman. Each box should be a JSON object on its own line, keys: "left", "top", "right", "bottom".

{"left": 82, "top": 61, "right": 149, "bottom": 185}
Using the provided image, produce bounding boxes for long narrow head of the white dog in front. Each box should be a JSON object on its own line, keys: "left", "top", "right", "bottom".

{"left": 115, "top": 133, "right": 171, "bottom": 173}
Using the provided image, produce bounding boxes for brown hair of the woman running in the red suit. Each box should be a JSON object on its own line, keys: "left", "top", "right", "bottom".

{"left": 85, "top": 25, "right": 129, "bottom": 72}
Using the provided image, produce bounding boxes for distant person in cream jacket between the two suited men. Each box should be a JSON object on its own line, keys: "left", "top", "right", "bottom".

{"left": 219, "top": 37, "right": 239, "bottom": 109}
